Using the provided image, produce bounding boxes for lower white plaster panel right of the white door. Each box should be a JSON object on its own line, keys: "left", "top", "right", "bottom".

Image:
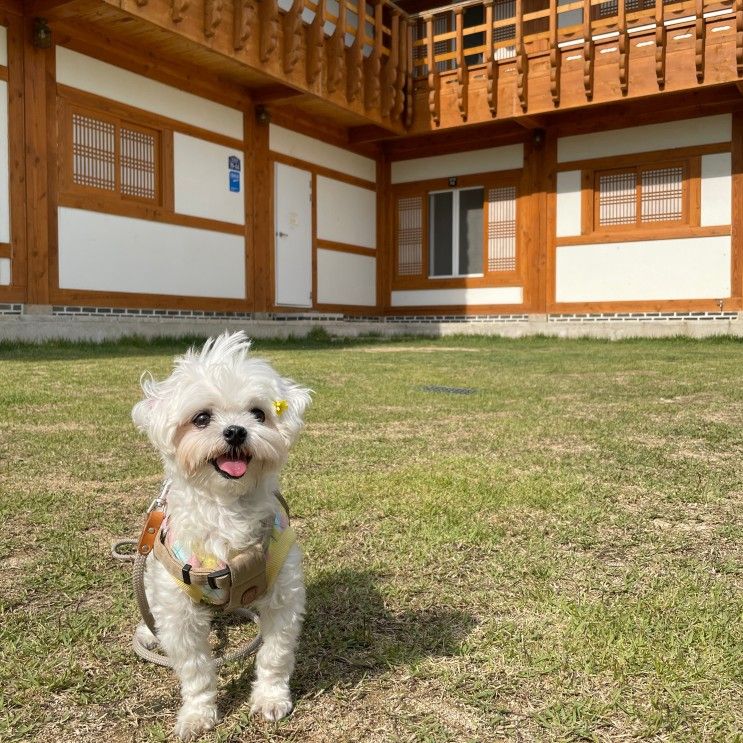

{"left": 317, "top": 248, "right": 377, "bottom": 307}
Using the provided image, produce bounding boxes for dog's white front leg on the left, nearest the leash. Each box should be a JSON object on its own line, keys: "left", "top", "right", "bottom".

{"left": 147, "top": 564, "right": 218, "bottom": 740}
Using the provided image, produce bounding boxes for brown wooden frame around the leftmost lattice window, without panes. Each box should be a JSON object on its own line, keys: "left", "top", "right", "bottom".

{"left": 59, "top": 100, "right": 166, "bottom": 208}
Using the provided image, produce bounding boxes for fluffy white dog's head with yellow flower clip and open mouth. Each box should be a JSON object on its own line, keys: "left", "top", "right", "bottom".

{"left": 132, "top": 331, "right": 310, "bottom": 493}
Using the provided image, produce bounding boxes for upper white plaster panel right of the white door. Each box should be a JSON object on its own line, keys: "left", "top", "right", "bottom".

{"left": 317, "top": 176, "right": 377, "bottom": 248}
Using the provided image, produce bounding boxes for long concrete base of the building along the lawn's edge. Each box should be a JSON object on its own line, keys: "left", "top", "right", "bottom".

{"left": 0, "top": 311, "right": 743, "bottom": 342}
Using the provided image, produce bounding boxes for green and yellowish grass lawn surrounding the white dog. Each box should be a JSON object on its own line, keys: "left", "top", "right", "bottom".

{"left": 0, "top": 338, "right": 743, "bottom": 743}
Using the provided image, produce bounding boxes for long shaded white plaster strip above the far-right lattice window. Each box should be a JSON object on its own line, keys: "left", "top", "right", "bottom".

{"left": 557, "top": 114, "right": 733, "bottom": 163}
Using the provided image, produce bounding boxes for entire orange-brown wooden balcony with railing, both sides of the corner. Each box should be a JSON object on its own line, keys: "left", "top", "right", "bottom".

{"left": 45, "top": 0, "right": 743, "bottom": 142}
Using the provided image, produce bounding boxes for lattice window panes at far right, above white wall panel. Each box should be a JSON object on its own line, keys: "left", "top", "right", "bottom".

{"left": 594, "top": 163, "right": 689, "bottom": 230}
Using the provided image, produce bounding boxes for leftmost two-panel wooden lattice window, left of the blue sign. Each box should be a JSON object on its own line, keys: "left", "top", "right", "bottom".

{"left": 67, "top": 108, "right": 161, "bottom": 203}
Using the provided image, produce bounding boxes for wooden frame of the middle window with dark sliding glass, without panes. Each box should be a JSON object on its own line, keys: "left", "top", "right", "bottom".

{"left": 388, "top": 169, "right": 527, "bottom": 289}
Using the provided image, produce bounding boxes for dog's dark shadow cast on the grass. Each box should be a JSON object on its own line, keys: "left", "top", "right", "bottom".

{"left": 223, "top": 570, "right": 475, "bottom": 714}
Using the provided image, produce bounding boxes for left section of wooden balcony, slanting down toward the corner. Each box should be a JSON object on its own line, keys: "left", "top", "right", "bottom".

{"left": 51, "top": 0, "right": 412, "bottom": 133}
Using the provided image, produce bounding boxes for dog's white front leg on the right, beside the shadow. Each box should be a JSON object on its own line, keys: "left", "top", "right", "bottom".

{"left": 250, "top": 546, "right": 305, "bottom": 721}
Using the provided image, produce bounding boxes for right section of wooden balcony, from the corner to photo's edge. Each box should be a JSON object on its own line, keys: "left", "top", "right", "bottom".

{"left": 408, "top": 0, "right": 743, "bottom": 132}
